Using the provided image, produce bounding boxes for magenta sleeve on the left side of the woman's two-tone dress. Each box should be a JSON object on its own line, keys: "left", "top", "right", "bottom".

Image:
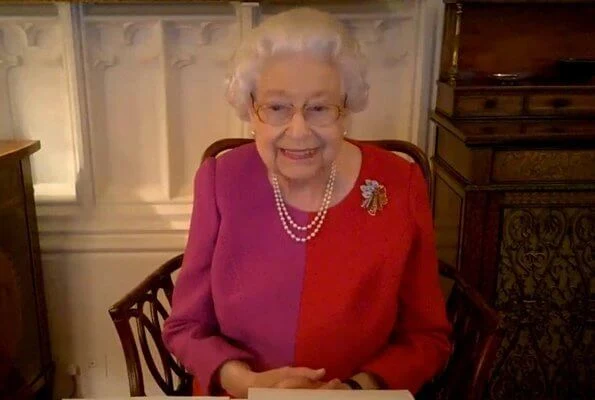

{"left": 163, "top": 158, "right": 251, "bottom": 393}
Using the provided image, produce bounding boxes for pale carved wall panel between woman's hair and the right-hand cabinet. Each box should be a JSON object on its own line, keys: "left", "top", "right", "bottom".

{"left": 262, "top": 1, "right": 422, "bottom": 141}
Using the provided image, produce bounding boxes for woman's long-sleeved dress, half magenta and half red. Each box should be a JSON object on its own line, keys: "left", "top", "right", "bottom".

{"left": 163, "top": 144, "right": 450, "bottom": 394}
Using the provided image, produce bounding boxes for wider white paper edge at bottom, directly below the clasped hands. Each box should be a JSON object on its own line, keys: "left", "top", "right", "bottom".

{"left": 248, "top": 388, "right": 414, "bottom": 400}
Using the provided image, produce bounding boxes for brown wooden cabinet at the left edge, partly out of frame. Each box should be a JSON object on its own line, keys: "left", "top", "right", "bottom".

{"left": 0, "top": 141, "right": 53, "bottom": 399}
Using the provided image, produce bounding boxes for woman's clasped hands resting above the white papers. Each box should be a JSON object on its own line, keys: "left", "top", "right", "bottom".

{"left": 219, "top": 361, "right": 349, "bottom": 398}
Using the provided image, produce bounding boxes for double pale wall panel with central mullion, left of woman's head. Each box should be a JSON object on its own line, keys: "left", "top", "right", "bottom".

{"left": 85, "top": 15, "right": 239, "bottom": 202}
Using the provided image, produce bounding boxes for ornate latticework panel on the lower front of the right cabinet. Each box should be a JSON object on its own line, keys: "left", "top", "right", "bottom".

{"left": 489, "top": 206, "right": 595, "bottom": 400}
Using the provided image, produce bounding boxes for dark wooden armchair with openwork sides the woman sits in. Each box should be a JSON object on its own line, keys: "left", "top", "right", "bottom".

{"left": 109, "top": 139, "right": 501, "bottom": 400}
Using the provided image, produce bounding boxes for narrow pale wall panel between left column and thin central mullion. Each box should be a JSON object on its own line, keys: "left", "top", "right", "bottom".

{"left": 84, "top": 18, "right": 167, "bottom": 201}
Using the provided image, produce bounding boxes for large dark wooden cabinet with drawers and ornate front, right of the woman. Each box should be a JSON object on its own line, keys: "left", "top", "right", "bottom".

{"left": 431, "top": 0, "right": 595, "bottom": 400}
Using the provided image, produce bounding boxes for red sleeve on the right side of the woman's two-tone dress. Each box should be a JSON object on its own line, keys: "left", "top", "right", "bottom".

{"left": 362, "top": 164, "right": 451, "bottom": 393}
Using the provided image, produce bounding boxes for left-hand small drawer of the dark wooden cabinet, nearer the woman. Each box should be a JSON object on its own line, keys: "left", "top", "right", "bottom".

{"left": 455, "top": 95, "right": 523, "bottom": 117}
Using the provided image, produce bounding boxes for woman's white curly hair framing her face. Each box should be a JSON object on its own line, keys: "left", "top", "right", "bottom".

{"left": 225, "top": 8, "right": 369, "bottom": 121}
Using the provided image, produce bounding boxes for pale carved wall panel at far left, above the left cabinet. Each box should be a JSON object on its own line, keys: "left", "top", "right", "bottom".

{"left": 0, "top": 15, "right": 76, "bottom": 195}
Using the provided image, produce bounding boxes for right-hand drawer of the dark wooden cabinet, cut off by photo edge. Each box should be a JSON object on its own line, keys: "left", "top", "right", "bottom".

{"left": 527, "top": 94, "right": 595, "bottom": 115}
